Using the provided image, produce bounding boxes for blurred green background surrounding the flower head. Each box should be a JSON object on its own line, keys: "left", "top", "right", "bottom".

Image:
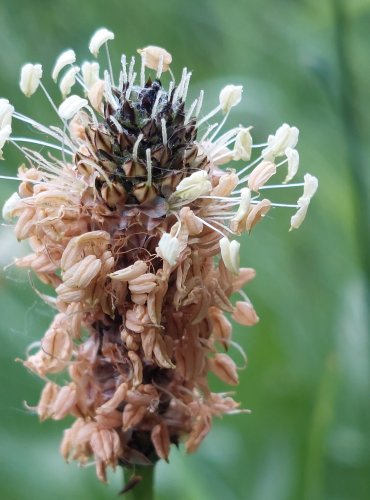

{"left": 0, "top": 0, "right": 370, "bottom": 500}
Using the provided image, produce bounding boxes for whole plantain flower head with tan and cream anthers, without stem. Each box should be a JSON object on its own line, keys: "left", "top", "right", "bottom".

{"left": 0, "top": 29, "right": 317, "bottom": 481}
